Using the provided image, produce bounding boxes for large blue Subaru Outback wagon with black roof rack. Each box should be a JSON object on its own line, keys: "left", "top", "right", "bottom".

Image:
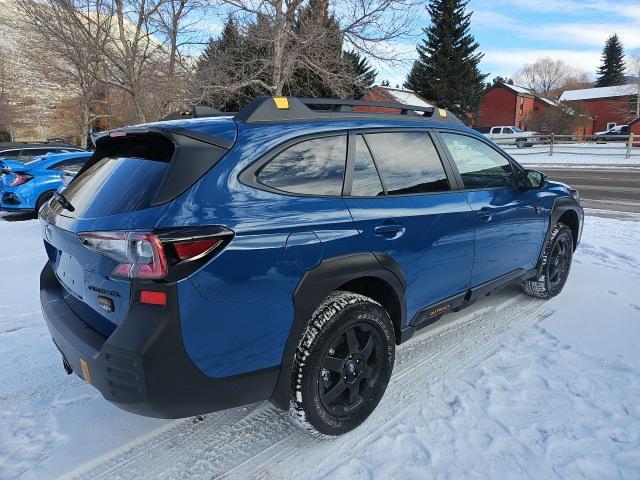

{"left": 40, "top": 97, "right": 583, "bottom": 435}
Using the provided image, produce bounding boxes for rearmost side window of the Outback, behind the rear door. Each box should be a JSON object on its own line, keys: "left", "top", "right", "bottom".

{"left": 258, "top": 135, "right": 347, "bottom": 195}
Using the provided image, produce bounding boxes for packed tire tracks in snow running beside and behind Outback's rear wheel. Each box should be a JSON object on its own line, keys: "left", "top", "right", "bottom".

{"left": 63, "top": 290, "right": 548, "bottom": 480}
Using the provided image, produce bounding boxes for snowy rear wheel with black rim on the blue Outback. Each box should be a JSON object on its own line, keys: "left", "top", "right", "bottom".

{"left": 290, "top": 291, "right": 395, "bottom": 436}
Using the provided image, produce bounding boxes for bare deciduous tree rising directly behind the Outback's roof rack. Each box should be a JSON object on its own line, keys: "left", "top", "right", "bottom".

{"left": 209, "top": 0, "right": 422, "bottom": 96}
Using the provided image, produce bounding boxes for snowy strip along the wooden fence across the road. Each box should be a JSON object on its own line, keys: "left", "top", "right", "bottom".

{"left": 502, "top": 143, "right": 640, "bottom": 167}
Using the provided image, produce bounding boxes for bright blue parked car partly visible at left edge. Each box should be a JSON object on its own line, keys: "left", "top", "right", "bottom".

{"left": 0, "top": 152, "right": 92, "bottom": 212}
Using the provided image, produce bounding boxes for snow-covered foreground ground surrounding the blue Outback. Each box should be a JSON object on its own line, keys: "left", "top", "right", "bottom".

{"left": 0, "top": 215, "right": 640, "bottom": 479}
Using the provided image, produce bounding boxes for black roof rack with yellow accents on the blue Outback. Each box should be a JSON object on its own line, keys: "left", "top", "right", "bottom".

{"left": 234, "top": 97, "right": 462, "bottom": 125}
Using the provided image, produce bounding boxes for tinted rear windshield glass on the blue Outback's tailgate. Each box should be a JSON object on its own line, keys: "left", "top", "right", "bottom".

{"left": 63, "top": 157, "right": 169, "bottom": 218}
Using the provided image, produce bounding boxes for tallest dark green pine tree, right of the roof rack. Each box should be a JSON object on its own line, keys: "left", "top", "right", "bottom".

{"left": 404, "top": 0, "right": 488, "bottom": 116}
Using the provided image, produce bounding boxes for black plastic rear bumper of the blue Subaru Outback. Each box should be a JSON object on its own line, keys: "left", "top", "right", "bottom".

{"left": 40, "top": 263, "right": 279, "bottom": 418}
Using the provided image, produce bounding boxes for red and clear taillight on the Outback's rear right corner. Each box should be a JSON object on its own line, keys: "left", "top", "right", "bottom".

{"left": 78, "top": 227, "right": 233, "bottom": 280}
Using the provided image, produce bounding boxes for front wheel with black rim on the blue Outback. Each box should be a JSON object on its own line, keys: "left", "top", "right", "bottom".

{"left": 522, "top": 223, "right": 574, "bottom": 298}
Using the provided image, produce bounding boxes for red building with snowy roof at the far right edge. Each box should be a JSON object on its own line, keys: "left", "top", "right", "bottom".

{"left": 560, "top": 85, "right": 638, "bottom": 132}
